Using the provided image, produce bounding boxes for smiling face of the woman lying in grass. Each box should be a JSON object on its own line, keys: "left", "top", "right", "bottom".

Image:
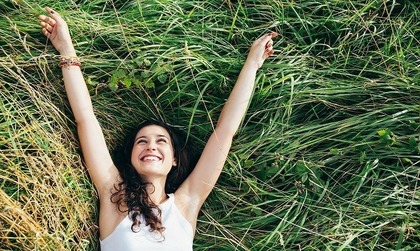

{"left": 131, "top": 125, "right": 176, "bottom": 180}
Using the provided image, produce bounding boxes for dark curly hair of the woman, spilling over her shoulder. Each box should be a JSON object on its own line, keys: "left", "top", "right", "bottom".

{"left": 111, "top": 120, "right": 198, "bottom": 233}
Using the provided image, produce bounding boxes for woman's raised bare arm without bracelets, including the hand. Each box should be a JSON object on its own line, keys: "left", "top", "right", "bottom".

{"left": 177, "top": 32, "right": 277, "bottom": 213}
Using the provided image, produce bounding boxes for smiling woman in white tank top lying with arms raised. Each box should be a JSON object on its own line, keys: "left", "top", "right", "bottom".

{"left": 39, "top": 8, "right": 277, "bottom": 250}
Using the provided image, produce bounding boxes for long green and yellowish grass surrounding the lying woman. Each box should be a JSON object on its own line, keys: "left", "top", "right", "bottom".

{"left": 0, "top": 0, "right": 420, "bottom": 250}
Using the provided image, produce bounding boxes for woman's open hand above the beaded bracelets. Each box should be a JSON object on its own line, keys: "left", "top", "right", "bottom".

{"left": 38, "top": 7, "right": 76, "bottom": 56}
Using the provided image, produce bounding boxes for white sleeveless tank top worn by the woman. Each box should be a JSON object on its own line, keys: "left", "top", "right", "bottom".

{"left": 100, "top": 194, "right": 194, "bottom": 251}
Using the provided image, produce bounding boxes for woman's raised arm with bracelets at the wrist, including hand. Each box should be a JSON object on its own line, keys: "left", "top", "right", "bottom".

{"left": 38, "top": 8, "right": 118, "bottom": 196}
